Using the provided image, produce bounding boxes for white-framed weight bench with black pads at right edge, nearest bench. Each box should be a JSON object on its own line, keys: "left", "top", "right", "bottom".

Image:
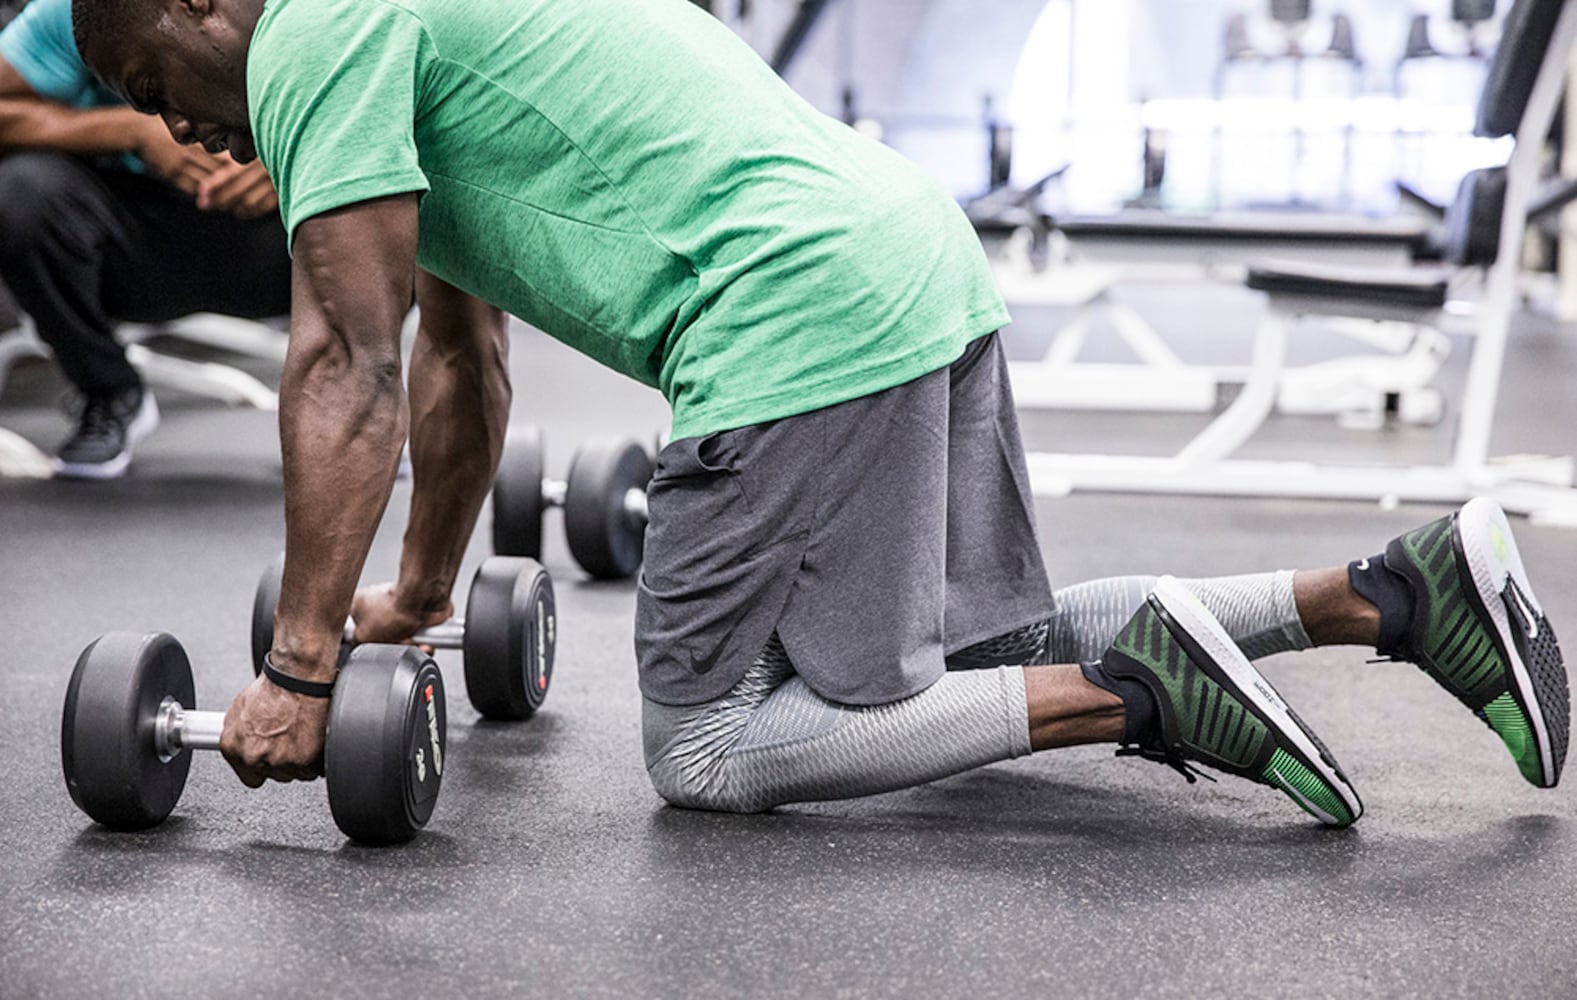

{"left": 1028, "top": 0, "right": 1577, "bottom": 527}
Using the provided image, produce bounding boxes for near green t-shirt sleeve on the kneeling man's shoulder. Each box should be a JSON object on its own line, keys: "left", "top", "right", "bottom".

{"left": 248, "top": 2, "right": 429, "bottom": 243}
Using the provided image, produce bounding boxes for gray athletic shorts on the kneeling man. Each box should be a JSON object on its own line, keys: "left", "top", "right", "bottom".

{"left": 636, "top": 334, "right": 1053, "bottom": 705}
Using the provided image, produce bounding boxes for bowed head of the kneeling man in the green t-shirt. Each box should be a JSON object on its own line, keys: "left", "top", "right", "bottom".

{"left": 82, "top": 3, "right": 257, "bottom": 162}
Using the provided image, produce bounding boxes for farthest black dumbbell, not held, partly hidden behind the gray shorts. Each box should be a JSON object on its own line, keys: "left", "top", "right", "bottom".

{"left": 492, "top": 426, "right": 651, "bottom": 580}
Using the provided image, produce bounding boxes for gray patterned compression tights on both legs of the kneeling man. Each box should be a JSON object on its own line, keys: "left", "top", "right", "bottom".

{"left": 643, "top": 573, "right": 1310, "bottom": 812}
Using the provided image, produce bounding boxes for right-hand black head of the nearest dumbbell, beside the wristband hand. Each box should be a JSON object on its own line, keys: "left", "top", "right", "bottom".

{"left": 323, "top": 644, "right": 448, "bottom": 844}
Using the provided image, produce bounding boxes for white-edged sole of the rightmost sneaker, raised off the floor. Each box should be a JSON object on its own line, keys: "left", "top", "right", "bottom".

{"left": 1451, "top": 497, "right": 1571, "bottom": 789}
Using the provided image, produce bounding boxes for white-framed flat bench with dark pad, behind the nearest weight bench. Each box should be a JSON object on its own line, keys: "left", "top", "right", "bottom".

{"left": 995, "top": 211, "right": 1449, "bottom": 427}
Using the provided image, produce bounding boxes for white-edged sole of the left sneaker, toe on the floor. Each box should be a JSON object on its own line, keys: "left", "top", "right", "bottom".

{"left": 1150, "top": 576, "right": 1364, "bottom": 826}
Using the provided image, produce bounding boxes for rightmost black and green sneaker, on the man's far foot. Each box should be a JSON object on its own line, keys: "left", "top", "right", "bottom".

{"left": 1380, "top": 497, "right": 1571, "bottom": 789}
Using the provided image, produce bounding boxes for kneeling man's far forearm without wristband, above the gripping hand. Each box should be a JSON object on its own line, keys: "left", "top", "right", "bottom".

{"left": 397, "top": 299, "right": 509, "bottom": 614}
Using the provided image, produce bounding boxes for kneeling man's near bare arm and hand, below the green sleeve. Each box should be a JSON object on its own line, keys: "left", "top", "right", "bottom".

{"left": 219, "top": 196, "right": 416, "bottom": 787}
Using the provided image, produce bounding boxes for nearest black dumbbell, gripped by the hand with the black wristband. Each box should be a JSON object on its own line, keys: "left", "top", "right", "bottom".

{"left": 60, "top": 632, "right": 446, "bottom": 844}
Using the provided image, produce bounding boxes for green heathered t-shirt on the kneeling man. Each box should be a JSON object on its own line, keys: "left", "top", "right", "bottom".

{"left": 246, "top": 0, "right": 1008, "bottom": 437}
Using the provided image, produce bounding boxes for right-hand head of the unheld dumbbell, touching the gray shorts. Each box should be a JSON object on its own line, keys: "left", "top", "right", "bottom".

{"left": 565, "top": 437, "right": 651, "bottom": 580}
